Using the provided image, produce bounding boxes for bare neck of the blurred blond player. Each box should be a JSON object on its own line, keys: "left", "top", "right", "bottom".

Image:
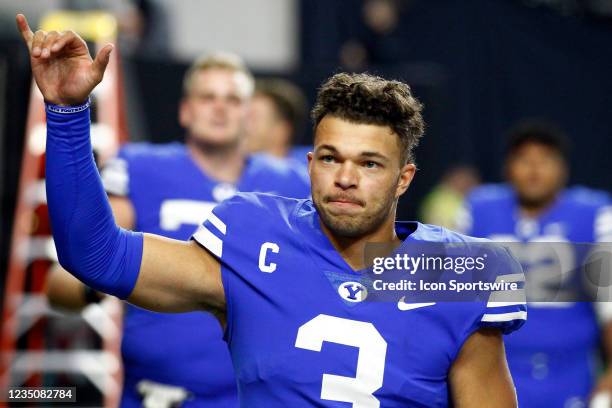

{"left": 186, "top": 138, "right": 246, "bottom": 183}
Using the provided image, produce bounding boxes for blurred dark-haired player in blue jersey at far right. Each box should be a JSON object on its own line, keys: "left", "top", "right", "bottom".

{"left": 459, "top": 121, "right": 612, "bottom": 408}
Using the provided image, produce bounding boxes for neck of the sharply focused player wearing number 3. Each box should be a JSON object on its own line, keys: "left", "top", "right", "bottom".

{"left": 321, "top": 216, "right": 401, "bottom": 270}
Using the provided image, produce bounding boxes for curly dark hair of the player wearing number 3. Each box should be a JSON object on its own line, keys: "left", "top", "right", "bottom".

{"left": 311, "top": 73, "right": 425, "bottom": 163}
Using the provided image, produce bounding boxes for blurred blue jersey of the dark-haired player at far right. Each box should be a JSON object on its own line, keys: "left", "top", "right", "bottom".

{"left": 459, "top": 184, "right": 612, "bottom": 408}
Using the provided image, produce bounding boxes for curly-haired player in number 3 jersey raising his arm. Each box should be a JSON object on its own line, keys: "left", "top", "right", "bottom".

{"left": 17, "top": 15, "right": 526, "bottom": 408}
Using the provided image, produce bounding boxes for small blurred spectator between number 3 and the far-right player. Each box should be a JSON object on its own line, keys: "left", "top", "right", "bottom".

{"left": 420, "top": 165, "right": 480, "bottom": 229}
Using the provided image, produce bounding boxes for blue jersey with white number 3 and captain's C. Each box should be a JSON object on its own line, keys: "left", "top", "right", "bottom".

{"left": 193, "top": 193, "right": 526, "bottom": 408}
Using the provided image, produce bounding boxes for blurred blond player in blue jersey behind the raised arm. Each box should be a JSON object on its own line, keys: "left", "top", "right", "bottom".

{"left": 48, "top": 53, "right": 310, "bottom": 407}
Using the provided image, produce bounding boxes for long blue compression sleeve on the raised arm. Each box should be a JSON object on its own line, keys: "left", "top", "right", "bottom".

{"left": 46, "top": 102, "right": 143, "bottom": 299}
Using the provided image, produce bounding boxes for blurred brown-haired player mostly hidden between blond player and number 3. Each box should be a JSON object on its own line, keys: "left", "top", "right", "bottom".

{"left": 247, "top": 78, "right": 312, "bottom": 164}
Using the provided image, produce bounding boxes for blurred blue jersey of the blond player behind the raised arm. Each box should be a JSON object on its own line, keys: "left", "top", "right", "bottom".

{"left": 102, "top": 143, "right": 310, "bottom": 407}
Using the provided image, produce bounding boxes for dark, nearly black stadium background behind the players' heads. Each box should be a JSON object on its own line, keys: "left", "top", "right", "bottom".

{"left": 0, "top": 0, "right": 612, "bottom": 302}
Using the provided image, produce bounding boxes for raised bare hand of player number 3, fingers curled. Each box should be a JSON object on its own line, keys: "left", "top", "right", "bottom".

{"left": 16, "top": 14, "right": 113, "bottom": 105}
